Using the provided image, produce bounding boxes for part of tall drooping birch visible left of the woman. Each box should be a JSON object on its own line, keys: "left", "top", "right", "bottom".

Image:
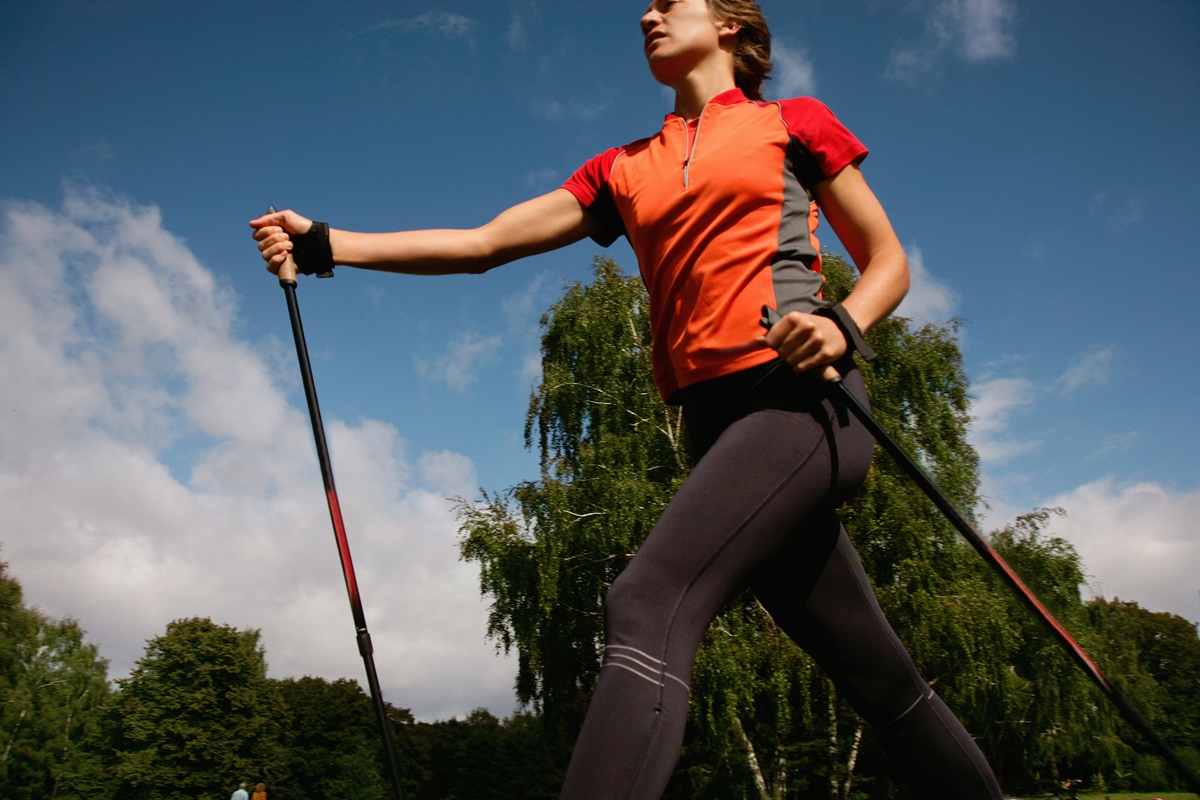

{"left": 458, "top": 258, "right": 686, "bottom": 739}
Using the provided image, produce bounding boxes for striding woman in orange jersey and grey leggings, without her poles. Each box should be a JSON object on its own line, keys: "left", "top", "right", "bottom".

{"left": 251, "top": 0, "right": 1001, "bottom": 800}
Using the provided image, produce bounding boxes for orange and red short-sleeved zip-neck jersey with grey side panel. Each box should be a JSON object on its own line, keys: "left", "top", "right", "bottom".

{"left": 563, "top": 89, "right": 866, "bottom": 401}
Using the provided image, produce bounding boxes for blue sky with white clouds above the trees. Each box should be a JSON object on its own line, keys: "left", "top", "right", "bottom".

{"left": 0, "top": 0, "right": 1200, "bottom": 720}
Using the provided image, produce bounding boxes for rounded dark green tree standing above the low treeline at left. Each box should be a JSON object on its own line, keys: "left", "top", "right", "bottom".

{"left": 108, "top": 618, "right": 286, "bottom": 800}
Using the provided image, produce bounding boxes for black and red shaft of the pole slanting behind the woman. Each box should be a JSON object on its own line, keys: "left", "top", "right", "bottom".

{"left": 830, "top": 377, "right": 1200, "bottom": 794}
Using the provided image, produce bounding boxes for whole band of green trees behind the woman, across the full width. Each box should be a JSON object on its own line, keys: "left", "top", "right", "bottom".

{"left": 0, "top": 257, "right": 1200, "bottom": 800}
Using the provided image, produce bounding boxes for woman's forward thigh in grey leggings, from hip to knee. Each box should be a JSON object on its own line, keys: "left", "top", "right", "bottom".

{"left": 608, "top": 391, "right": 870, "bottom": 669}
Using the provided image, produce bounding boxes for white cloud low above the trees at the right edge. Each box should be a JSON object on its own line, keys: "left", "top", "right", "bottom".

{"left": 1043, "top": 477, "right": 1200, "bottom": 621}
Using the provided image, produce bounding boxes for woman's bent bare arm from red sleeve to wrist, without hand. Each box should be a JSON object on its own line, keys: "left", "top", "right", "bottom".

{"left": 816, "top": 164, "right": 908, "bottom": 332}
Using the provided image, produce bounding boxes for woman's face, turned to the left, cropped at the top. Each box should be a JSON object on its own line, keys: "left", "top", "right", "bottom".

{"left": 642, "top": 0, "right": 737, "bottom": 85}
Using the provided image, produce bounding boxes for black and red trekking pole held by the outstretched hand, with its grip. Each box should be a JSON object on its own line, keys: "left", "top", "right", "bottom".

{"left": 268, "top": 205, "right": 404, "bottom": 800}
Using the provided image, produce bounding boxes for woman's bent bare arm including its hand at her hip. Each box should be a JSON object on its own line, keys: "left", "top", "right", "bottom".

{"left": 760, "top": 164, "right": 908, "bottom": 378}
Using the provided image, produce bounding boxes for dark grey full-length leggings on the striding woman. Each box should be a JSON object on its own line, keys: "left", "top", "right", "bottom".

{"left": 562, "top": 362, "right": 1002, "bottom": 800}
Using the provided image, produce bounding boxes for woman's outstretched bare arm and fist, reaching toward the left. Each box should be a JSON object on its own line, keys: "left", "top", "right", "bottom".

{"left": 250, "top": 188, "right": 599, "bottom": 275}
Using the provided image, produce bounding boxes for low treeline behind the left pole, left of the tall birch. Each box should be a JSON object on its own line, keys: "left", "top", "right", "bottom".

{"left": 0, "top": 582, "right": 564, "bottom": 800}
